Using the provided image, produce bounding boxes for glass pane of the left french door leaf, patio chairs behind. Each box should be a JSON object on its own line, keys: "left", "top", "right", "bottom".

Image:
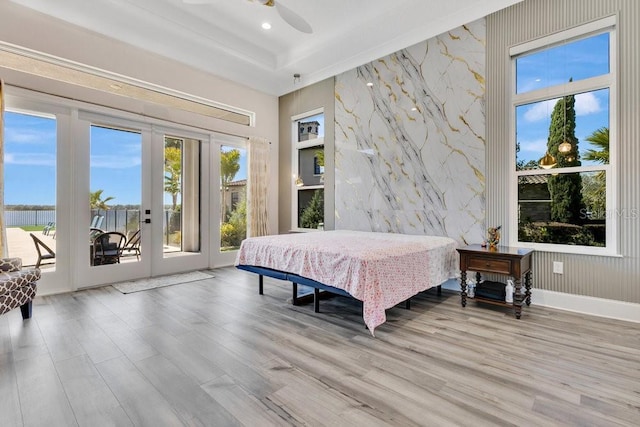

{"left": 87, "top": 125, "right": 144, "bottom": 266}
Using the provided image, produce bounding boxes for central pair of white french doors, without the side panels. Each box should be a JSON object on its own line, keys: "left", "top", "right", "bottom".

{"left": 74, "top": 113, "right": 209, "bottom": 288}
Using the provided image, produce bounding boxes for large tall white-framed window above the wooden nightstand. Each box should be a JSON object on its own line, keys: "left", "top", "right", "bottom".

{"left": 510, "top": 18, "right": 619, "bottom": 254}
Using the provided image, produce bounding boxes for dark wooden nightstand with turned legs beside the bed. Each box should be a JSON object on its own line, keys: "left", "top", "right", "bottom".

{"left": 458, "top": 245, "right": 533, "bottom": 319}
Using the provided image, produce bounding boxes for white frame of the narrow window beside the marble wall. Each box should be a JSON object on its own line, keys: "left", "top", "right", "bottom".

{"left": 291, "top": 107, "right": 324, "bottom": 232}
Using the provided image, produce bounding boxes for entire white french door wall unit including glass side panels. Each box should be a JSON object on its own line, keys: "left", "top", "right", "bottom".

{"left": 3, "top": 88, "right": 240, "bottom": 295}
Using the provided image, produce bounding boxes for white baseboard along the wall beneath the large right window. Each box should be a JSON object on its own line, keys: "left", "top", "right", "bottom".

{"left": 442, "top": 279, "right": 640, "bottom": 323}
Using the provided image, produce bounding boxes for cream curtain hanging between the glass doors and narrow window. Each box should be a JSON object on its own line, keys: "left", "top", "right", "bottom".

{"left": 247, "top": 137, "right": 270, "bottom": 237}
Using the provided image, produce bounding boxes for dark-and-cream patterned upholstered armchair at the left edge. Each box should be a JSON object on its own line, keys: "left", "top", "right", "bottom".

{"left": 0, "top": 258, "right": 40, "bottom": 319}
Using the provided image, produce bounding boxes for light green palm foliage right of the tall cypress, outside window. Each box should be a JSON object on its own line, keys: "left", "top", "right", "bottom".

{"left": 583, "top": 127, "right": 609, "bottom": 218}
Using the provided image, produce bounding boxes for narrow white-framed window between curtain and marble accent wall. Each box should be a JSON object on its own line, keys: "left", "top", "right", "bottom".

{"left": 292, "top": 109, "right": 324, "bottom": 230}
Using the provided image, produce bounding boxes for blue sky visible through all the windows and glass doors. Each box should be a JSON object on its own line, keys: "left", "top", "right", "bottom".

{"left": 4, "top": 33, "right": 609, "bottom": 205}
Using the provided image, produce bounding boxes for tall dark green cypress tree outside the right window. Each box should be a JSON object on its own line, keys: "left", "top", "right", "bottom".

{"left": 547, "top": 90, "right": 584, "bottom": 224}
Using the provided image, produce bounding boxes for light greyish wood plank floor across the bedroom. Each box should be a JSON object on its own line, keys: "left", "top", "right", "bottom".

{"left": 0, "top": 268, "right": 640, "bottom": 427}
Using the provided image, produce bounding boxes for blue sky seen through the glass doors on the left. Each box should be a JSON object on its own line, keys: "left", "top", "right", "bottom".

{"left": 4, "top": 111, "right": 247, "bottom": 205}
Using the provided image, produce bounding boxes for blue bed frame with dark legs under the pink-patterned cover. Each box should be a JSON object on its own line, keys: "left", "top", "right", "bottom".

{"left": 236, "top": 264, "right": 442, "bottom": 313}
